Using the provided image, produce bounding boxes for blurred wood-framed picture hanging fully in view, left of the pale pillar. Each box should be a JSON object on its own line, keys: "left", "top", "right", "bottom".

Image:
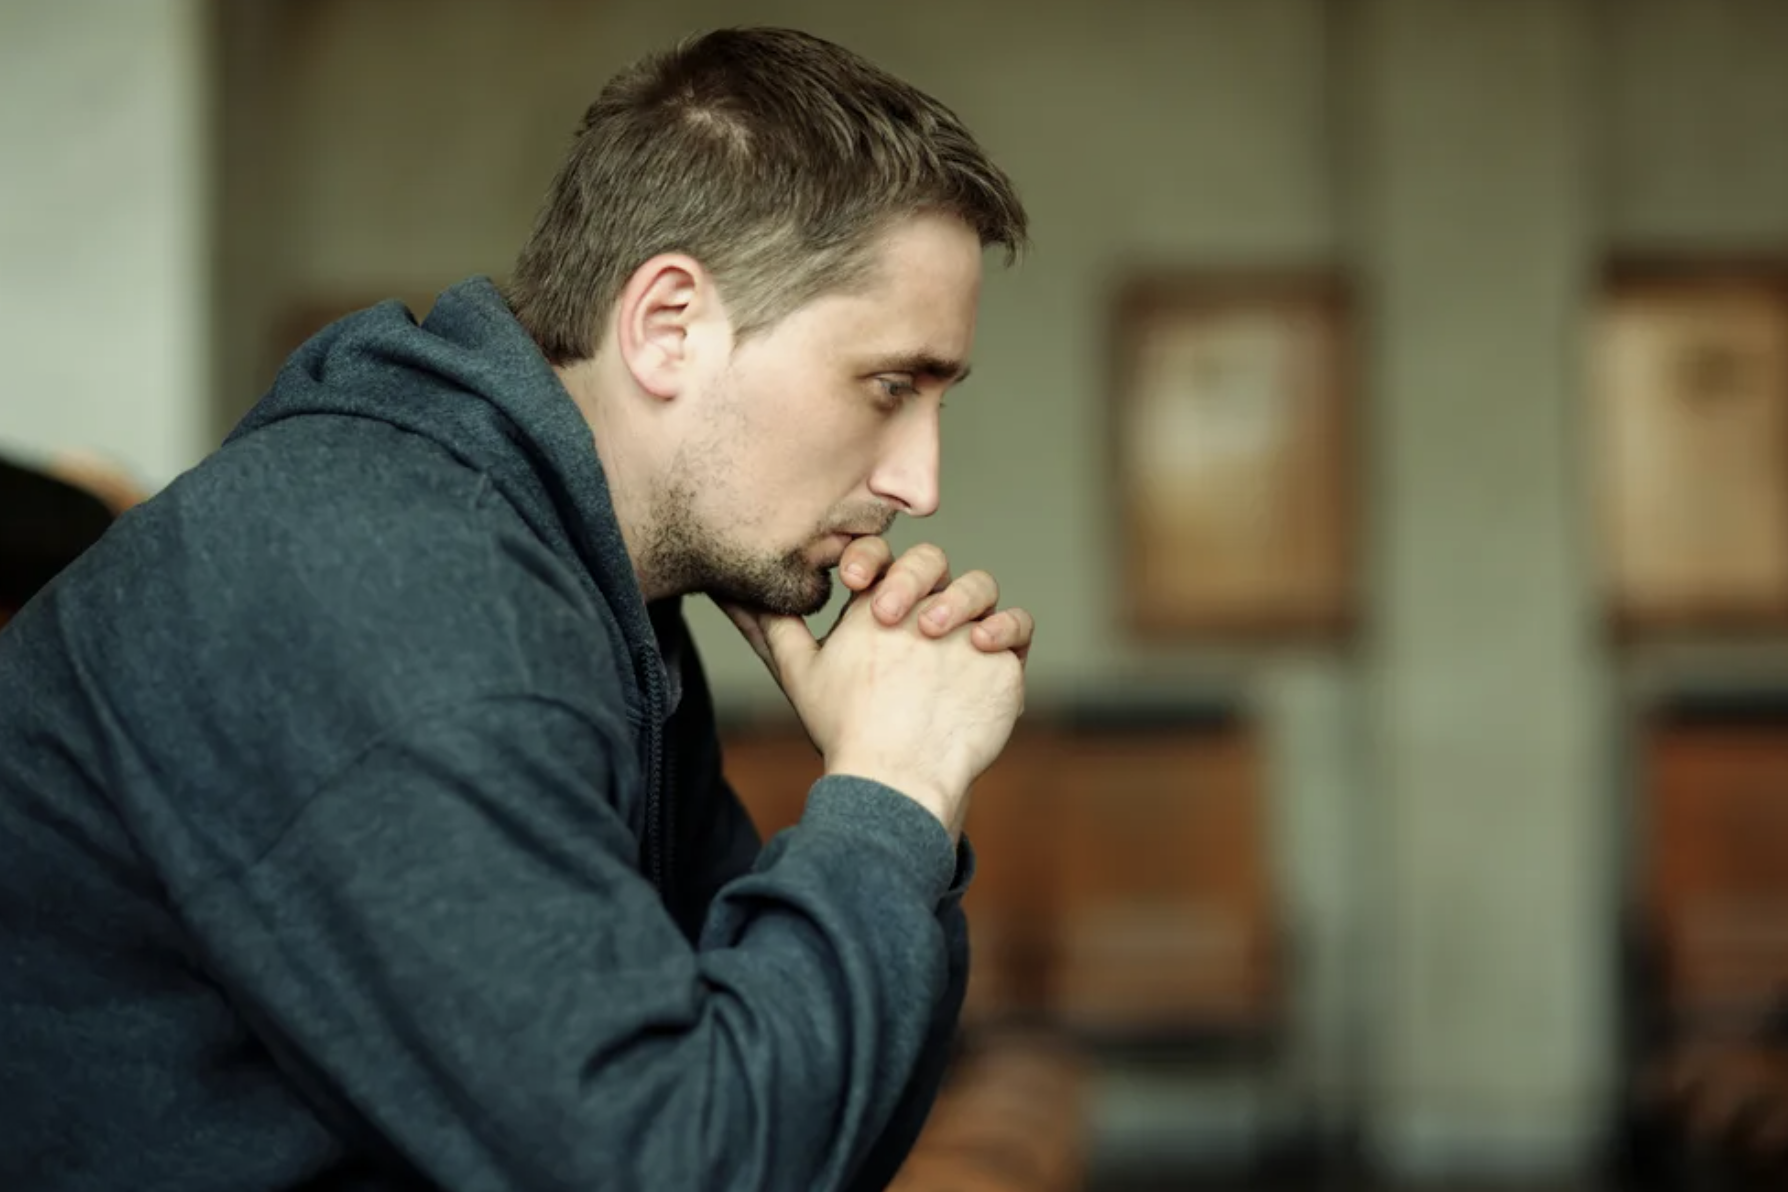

{"left": 1110, "top": 275, "right": 1357, "bottom": 640}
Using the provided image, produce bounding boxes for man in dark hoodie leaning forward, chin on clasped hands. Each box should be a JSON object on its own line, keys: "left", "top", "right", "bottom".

{"left": 0, "top": 30, "right": 1032, "bottom": 1192}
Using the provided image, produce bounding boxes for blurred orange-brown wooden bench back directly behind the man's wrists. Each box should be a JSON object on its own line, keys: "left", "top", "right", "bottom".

{"left": 724, "top": 713, "right": 1284, "bottom": 1044}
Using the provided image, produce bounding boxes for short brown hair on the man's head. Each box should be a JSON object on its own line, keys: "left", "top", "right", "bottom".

{"left": 506, "top": 29, "right": 1026, "bottom": 365}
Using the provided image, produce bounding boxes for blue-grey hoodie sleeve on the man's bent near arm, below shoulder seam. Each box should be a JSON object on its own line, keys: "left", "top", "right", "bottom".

{"left": 186, "top": 697, "right": 958, "bottom": 1188}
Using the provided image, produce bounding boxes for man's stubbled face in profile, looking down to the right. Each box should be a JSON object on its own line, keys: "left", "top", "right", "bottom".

{"left": 647, "top": 214, "right": 982, "bottom": 617}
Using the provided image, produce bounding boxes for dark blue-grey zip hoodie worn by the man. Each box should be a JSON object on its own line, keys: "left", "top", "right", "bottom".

{"left": 0, "top": 279, "right": 973, "bottom": 1192}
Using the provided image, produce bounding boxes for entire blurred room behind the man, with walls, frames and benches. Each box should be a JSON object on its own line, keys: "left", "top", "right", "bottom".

{"left": 0, "top": 0, "right": 1788, "bottom": 1192}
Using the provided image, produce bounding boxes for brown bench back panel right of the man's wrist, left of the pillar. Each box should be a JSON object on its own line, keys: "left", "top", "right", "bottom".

{"left": 1044, "top": 717, "right": 1282, "bottom": 1044}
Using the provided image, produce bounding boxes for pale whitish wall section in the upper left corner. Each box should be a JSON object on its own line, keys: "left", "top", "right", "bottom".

{"left": 0, "top": 0, "right": 211, "bottom": 486}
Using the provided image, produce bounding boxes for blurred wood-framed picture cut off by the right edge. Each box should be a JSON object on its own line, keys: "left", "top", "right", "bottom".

{"left": 1586, "top": 266, "right": 1788, "bottom": 633}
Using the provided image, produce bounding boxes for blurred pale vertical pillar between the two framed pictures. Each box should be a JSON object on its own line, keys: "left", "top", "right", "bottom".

{"left": 1352, "top": 0, "right": 1613, "bottom": 1174}
